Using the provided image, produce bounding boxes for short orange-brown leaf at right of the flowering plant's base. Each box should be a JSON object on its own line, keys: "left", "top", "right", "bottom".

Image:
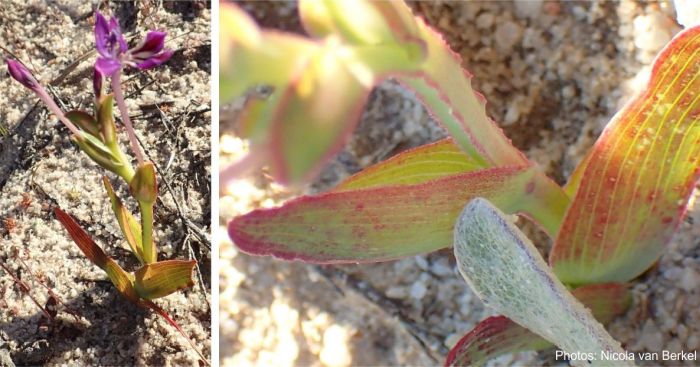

{"left": 134, "top": 260, "right": 197, "bottom": 300}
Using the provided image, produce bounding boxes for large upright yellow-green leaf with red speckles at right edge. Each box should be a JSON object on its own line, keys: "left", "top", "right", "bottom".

{"left": 550, "top": 27, "right": 700, "bottom": 284}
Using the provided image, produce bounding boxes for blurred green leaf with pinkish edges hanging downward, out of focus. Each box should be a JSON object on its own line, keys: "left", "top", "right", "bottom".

{"left": 268, "top": 50, "right": 370, "bottom": 183}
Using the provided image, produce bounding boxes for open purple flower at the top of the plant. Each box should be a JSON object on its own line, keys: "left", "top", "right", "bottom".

{"left": 95, "top": 12, "right": 173, "bottom": 76}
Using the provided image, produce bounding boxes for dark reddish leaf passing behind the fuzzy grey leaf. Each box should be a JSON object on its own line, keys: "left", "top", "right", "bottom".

{"left": 445, "top": 283, "right": 632, "bottom": 366}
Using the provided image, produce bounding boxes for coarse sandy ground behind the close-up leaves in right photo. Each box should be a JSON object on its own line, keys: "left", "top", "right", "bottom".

{"left": 219, "top": 1, "right": 700, "bottom": 367}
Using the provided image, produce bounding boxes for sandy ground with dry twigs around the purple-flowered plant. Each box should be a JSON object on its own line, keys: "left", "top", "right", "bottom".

{"left": 0, "top": 0, "right": 211, "bottom": 365}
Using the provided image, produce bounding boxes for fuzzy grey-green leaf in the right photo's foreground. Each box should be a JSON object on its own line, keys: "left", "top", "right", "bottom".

{"left": 454, "top": 198, "right": 624, "bottom": 366}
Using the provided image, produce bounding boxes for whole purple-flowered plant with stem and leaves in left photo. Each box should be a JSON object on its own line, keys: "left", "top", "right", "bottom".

{"left": 7, "top": 12, "right": 207, "bottom": 363}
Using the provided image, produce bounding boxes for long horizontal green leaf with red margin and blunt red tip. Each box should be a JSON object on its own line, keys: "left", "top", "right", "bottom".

{"left": 229, "top": 167, "right": 564, "bottom": 263}
